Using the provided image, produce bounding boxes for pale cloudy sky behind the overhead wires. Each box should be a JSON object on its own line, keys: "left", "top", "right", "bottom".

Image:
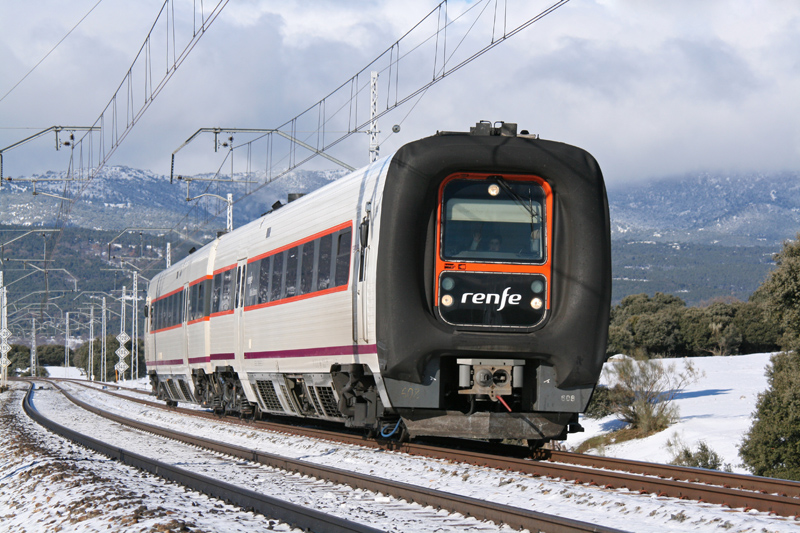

{"left": 0, "top": 0, "right": 800, "bottom": 185}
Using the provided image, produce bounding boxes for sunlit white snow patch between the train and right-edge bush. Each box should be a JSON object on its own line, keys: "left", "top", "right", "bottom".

{"left": 567, "top": 353, "right": 772, "bottom": 474}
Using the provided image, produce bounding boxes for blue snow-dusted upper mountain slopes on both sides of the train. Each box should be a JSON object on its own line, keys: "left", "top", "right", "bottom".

{"left": 0, "top": 166, "right": 800, "bottom": 246}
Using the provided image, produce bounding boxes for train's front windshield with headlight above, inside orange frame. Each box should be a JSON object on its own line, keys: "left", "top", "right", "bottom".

{"left": 442, "top": 176, "right": 546, "bottom": 263}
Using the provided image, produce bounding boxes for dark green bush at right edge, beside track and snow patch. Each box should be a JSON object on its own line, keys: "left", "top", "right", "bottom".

{"left": 739, "top": 351, "right": 800, "bottom": 481}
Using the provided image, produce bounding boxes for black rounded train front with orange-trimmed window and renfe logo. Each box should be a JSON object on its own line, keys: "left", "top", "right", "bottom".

{"left": 376, "top": 122, "right": 610, "bottom": 443}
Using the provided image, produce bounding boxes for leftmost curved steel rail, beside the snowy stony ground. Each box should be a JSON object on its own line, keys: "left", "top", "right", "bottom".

{"left": 22, "top": 383, "right": 380, "bottom": 533}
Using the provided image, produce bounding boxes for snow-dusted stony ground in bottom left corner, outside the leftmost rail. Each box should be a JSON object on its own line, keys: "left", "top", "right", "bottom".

{"left": 0, "top": 382, "right": 304, "bottom": 533}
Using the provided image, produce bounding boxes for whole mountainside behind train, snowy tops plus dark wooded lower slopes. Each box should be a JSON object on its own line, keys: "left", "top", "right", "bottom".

{"left": 0, "top": 166, "right": 800, "bottom": 324}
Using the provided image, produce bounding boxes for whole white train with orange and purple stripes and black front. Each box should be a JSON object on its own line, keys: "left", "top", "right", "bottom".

{"left": 145, "top": 122, "right": 610, "bottom": 441}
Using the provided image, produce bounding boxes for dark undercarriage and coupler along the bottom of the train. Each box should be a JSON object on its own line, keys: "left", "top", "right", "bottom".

{"left": 150, "top": 360, "right": 592, "bottom": 447}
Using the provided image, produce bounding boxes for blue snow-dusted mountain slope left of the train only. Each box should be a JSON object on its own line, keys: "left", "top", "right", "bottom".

{"left": 0, "top": 166, "right": 345, "bottom": 230}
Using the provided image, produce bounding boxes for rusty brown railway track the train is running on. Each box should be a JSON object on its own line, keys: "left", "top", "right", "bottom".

{"left": 59, "top": 383, "right": 800, "bottom": 517}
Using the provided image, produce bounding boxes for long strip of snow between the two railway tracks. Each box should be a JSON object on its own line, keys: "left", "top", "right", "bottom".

{"left": 40, "top": 368, "right": 798, "bottom": 533}
